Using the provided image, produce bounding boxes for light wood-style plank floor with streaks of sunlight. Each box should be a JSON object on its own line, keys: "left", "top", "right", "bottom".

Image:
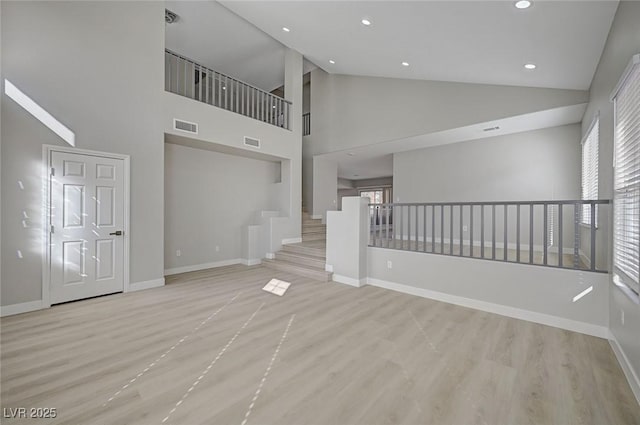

{"left": 0, "top": 265, "right": 640, "bottom": 425}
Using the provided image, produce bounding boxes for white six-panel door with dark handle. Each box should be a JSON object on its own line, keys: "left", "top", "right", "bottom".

{"left": 50, "top": 151, "right": 125, "bottom": 304}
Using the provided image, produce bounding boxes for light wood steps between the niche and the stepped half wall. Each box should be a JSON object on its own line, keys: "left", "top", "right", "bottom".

{"left": 262, "top": 211, "right": 333, "bottom": 282}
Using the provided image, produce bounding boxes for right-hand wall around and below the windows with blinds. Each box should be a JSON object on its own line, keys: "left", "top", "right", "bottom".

{"left": 582, "top": 1, "right": 640, "bottom": 399}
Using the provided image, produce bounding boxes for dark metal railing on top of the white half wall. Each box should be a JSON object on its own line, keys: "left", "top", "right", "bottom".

{"left": 369, "top": 200, "right": 609, "bottom": 273}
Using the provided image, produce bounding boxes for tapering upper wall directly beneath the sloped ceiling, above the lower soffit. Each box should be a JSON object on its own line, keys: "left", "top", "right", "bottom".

{"left": 305, "top": 70, "right": 588, "bottom": 156}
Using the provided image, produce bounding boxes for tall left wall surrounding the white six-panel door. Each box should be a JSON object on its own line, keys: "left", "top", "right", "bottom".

{"left": 0, "top": 2, "right": 164, "bottom": 306}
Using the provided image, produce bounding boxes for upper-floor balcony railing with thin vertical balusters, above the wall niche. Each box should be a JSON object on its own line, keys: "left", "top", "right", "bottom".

{"left": 164, "top": 49, "right": 291, "bottom": 130}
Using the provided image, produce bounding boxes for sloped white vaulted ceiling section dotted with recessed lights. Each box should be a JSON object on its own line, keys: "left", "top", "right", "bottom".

{"left": 221, "top": 0, "right": 617, "bottom": 90}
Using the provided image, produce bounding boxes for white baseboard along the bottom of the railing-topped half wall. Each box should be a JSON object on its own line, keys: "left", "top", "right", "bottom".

{"left": 367, "top": 278, "right": 610, "bottom": 338}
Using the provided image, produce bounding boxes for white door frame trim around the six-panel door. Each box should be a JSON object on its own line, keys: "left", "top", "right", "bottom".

{"left": 42, "top": 145, "right": 131, "bottom": 308}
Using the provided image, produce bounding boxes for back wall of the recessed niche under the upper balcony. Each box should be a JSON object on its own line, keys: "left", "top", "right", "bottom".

{"left": 164, "top": 143, "right": 280, "bottom": 269}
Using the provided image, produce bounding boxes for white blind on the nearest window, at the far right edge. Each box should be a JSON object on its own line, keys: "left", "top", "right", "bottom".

{"left": 613, "top": 55, "right": 640, "bottom": 293}
